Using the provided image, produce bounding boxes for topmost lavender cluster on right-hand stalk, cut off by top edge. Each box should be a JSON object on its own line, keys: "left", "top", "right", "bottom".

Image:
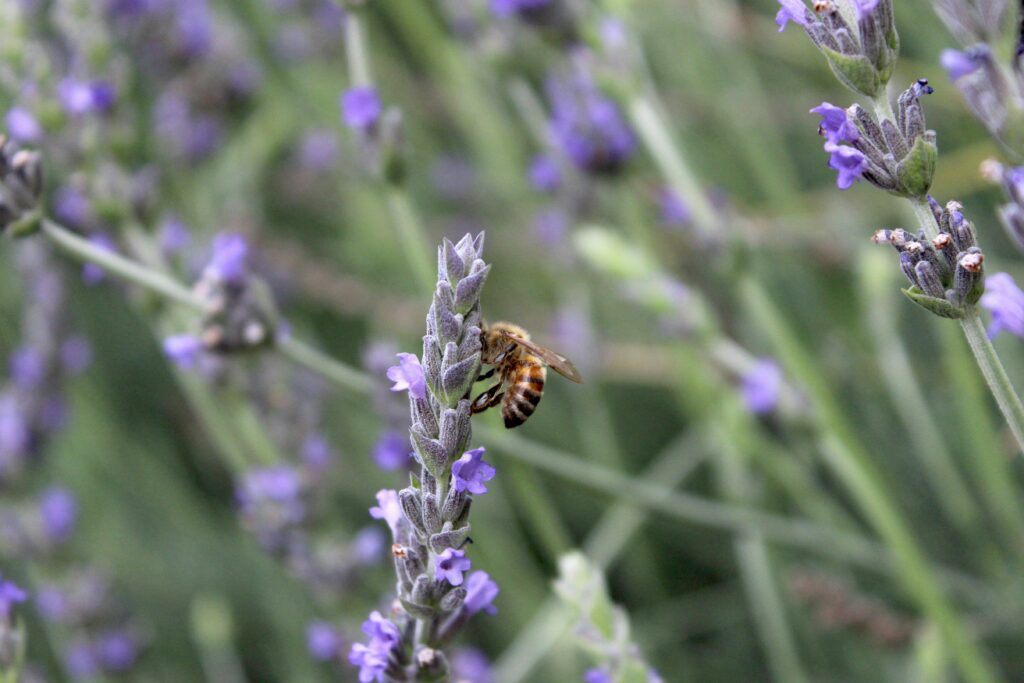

{"left": 775, "top": 0, "right": 899, "bottom": 97}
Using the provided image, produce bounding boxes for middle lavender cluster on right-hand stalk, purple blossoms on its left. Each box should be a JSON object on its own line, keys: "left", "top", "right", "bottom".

{"left": 811, "top": 79, "right": 938, "bottom": 198}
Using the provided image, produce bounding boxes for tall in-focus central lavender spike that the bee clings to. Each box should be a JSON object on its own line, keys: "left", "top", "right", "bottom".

{"left": 349, "top": 233, "right": 498, "bottom": 681}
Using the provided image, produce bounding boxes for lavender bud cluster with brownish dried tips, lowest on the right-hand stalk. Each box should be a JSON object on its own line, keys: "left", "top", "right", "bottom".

{"left": 871, "top": 198, "right": 985, "bottom": 318}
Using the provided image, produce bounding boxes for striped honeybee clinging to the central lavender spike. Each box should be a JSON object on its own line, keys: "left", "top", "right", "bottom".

{"left": 472, "top": 323, "right": 583, "bottom": 429}
